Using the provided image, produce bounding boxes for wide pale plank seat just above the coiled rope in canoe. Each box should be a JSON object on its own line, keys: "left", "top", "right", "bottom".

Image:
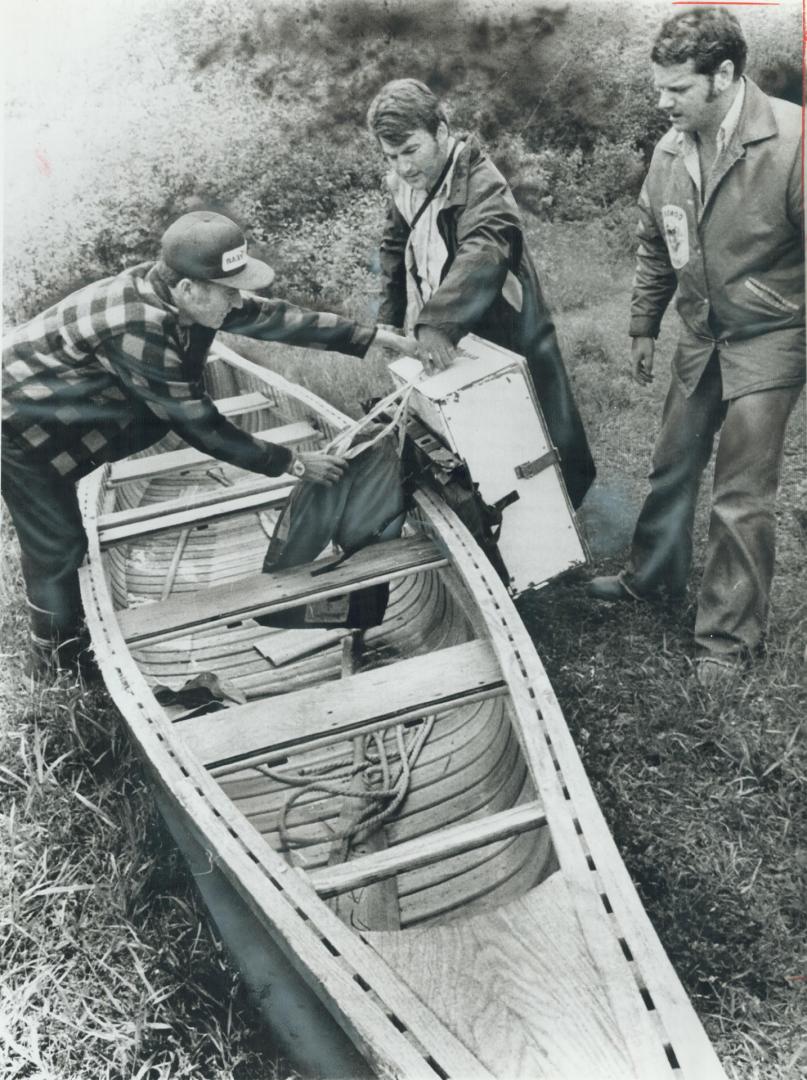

{"left": 178, "top": 642, "right": 505, "bottom": 768}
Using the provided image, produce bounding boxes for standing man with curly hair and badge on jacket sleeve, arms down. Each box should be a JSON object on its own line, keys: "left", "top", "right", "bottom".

{"left": 589, "top": 8, "right": 805, "bottom": 687}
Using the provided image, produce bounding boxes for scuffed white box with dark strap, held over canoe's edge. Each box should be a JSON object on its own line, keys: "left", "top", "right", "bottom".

{"left": 390, "top": 334, "right": 587, "bottom": 596}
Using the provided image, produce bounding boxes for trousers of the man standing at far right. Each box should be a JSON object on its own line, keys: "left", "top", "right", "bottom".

{"left": 622, "top": 354, "right": 801, "bottom": 659}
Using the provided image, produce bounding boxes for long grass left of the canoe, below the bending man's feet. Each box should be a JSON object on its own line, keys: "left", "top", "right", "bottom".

{"left": 0, "top": 530, "right": 289, "bottom": 1080}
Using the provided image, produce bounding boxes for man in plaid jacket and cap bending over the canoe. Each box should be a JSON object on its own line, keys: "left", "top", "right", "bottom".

{"left": 2, "top": 211, "right": 417, "bottom": 671}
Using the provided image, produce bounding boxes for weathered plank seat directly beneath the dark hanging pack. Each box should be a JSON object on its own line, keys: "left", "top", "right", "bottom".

{"left": 118, "top": 537, "right": 447, "bottom": 643}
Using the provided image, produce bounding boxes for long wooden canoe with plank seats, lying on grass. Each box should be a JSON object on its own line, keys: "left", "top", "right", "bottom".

{"left": 81, "top": 346, "right": 724, "bottom": 1080}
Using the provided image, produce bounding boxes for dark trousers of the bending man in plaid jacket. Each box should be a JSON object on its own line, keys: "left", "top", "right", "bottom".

{"left": 1, "top": 438, "right": 86, "bottom": 649}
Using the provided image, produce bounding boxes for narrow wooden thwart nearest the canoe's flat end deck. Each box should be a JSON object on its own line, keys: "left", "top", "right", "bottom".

{"left": 308, "top": 801, "right": 547, "bottom": 897}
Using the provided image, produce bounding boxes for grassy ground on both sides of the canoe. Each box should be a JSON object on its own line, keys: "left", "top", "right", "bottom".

{"left": 0, "top": 212, "right": 807, "bottom": 1080}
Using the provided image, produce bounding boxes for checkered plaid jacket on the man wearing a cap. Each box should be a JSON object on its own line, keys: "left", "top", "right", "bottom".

{"left": 2, "top": 264, "right": 375, "bottom": 481}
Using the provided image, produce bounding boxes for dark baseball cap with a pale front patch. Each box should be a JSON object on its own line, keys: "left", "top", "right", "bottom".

{"left": 161, "top": 210, "right": 274, "bottom": 288}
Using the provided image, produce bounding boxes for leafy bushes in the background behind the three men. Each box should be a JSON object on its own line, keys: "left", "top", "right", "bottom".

{"left": 5, "top": 0, "right": 801, "bottom": 321}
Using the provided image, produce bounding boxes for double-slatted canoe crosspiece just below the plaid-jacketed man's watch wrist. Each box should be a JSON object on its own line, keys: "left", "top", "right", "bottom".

{"left": 97, "top": 473, "right": 296, "bottom": 548}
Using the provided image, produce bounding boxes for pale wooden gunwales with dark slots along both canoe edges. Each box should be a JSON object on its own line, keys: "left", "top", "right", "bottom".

{"left": 80, "top": 346, "right": 725, "bottom": 1080}
